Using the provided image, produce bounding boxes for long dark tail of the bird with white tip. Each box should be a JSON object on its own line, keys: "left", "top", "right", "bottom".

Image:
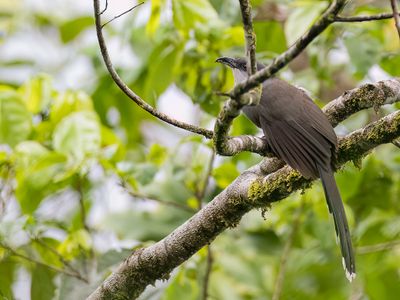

{"left": 318, "top": 167, "right": 356, "bottom": 282}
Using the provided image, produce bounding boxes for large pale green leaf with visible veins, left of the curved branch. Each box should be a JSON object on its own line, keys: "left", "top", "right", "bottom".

{"left": 53, "top": 111, "right": 101, "bottom": 163}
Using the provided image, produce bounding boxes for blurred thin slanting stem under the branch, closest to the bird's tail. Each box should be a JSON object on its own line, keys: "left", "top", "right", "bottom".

{"left": 272, "top": 196, "right": 304, "bottom": 300}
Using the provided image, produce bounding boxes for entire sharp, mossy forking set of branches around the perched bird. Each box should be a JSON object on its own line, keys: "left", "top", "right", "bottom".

{"left": 88, "top": 0, "right": 400, "bottom": 300}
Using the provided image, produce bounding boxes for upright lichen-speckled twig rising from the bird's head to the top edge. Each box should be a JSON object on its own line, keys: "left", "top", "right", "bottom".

{"left": 239, "top": 0, "right": 257, "bottom": 76}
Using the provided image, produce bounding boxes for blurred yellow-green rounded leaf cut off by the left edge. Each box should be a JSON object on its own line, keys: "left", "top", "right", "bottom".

{"left": 0, "top": 91, "right": 32, "bottom": 146}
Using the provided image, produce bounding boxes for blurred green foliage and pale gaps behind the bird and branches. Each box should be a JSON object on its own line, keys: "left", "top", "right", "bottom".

{"left": 0, "top": 0, "right": 400, "bottom": 300}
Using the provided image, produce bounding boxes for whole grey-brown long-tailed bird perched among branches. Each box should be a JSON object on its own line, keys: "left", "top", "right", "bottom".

{"left": 216, "top": 57, "right": 356, "bottom": 282}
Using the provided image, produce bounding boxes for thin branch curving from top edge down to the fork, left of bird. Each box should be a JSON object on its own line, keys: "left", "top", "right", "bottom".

{"left": 93, "top": 0, "right": 213, "bottom": 138}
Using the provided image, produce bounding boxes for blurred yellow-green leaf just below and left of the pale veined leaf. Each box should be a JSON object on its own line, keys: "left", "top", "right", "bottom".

{"left": 15, "top": 152, "right": 69, "bottom": 213}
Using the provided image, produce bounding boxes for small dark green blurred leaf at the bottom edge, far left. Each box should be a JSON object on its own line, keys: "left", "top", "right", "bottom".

{"left": 31, "top": 265, "right": 56, "bottom": 300}
